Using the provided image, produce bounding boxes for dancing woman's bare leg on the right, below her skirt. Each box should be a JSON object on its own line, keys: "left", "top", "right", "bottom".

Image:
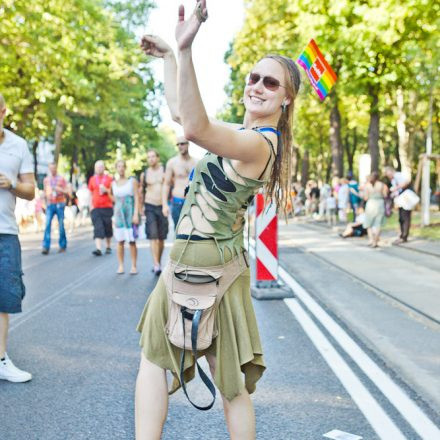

{"left": 206, "top": 355, "right": 256, "bottom": 440}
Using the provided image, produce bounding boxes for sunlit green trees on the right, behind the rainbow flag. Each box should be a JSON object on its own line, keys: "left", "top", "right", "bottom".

{"left": 223, "top": 0, "right": 440, "bottom": 181}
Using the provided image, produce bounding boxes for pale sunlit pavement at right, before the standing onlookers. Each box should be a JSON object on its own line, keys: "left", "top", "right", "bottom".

{"left": 280, "top": 218, "right": 440, "bottom": 324}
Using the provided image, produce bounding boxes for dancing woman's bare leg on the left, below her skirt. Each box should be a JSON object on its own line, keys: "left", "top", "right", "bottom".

{"left": 135, "top": 354, "right": 168, "bottom": 440}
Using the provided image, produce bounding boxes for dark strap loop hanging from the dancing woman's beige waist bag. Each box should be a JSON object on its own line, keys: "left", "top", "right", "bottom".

{"left": 180, "top": 306, "right": 216, "bottom": 411}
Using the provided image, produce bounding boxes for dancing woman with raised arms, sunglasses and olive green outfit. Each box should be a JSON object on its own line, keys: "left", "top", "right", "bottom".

{"left": 136, "top": 0, "right": 300, "bottom": 440}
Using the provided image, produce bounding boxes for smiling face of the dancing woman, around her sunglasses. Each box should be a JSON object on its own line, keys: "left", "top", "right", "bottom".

{"left": 243, "top": 58, "right": 290, "bottom": 117}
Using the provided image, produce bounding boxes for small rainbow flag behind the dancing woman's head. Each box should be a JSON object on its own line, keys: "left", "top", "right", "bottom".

{"left": 296, "top": 38, "right": 338, "bottom": 101}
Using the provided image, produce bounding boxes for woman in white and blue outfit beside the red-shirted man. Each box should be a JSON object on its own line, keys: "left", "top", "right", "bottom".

{"left": 112, "top": 160, "right": 139, "bottom": 275}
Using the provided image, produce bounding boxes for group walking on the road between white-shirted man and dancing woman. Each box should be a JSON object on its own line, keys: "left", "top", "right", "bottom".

{"left": 37, "top": 146, "right": 196, "bottom": 275}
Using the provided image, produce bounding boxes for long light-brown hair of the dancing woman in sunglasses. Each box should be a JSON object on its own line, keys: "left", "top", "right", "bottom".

{"left": 262, "top": 54, "right": 301, "bottom": 211}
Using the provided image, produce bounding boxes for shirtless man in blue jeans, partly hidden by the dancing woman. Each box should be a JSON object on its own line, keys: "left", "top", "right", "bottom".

{"left": 162, "top": 137, "right": 196, "bottom": 230}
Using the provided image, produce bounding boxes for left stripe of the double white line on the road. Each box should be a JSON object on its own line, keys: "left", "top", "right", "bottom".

{"left": 284, "top": 298, "right": 406, "bottom": 440}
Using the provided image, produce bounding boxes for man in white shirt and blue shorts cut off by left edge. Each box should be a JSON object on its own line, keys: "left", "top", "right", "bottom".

{"left": 0, "top": 94, "right": 35, "bottom": 382}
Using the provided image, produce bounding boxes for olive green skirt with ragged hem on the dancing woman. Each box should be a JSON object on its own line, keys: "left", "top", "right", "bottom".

{"left": 137, "top": 240, "right": 266, "bottom": 400}
